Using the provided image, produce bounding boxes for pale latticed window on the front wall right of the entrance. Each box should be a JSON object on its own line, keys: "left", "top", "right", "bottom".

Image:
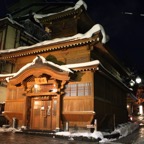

{"left": 65, "top": 83, "right": 91, "bottom": 96}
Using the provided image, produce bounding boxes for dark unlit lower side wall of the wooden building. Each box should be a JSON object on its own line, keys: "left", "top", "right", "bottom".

{"left": 94, "top": 72, "right": 128, "bottom": 128}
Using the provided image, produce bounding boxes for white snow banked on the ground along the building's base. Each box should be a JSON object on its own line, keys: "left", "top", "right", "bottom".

{"left": 0, "top": 122, "right": 139, "bottom": 143}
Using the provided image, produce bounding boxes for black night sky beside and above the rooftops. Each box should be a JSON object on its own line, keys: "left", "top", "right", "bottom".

{"left": 0, "top": 0, "right": 144, "bottom": 76}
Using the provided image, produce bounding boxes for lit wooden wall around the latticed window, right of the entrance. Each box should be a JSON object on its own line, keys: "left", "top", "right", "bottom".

{"left": 62, "top": 72, "right": 95, "bottom": 127}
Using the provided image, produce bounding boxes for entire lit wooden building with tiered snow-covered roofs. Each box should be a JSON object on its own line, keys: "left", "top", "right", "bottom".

{"left": 0, "top": 0, "right": 134, "bottom": 130}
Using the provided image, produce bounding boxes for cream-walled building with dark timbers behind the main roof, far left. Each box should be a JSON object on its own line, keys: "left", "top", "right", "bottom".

{"left": 0, "top": 17, "right": 40, "bottom": 50}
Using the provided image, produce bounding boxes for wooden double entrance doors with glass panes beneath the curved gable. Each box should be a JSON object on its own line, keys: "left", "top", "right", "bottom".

{"left": 30, "top": 98, "right": 57, "bottom": 130}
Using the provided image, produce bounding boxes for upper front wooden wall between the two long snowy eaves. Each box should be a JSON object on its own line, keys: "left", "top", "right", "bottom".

{"left": 15, "top": 46, "right": 90, "bottom": 71}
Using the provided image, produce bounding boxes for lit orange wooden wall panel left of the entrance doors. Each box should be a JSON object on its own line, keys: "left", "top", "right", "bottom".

{"left": 4, "top": 87, "right": 26, "bottom": 125}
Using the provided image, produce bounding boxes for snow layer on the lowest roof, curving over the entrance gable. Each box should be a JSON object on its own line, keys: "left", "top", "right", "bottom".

{"left": 0, "top": 56, "right": 99, "bottom": 82}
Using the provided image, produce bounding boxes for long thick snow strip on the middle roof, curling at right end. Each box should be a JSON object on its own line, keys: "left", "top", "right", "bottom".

{"left": 1, "top": 24, "right": 107, "bottom": 53}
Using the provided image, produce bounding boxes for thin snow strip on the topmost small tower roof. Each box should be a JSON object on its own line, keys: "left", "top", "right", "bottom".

{"left": 34, "top": 0, "right": 87, "bottom": 22}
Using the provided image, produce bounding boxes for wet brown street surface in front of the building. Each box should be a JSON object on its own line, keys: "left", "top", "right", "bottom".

{"left": 0, "top": 127, "right": 144, "bottom": 144}
